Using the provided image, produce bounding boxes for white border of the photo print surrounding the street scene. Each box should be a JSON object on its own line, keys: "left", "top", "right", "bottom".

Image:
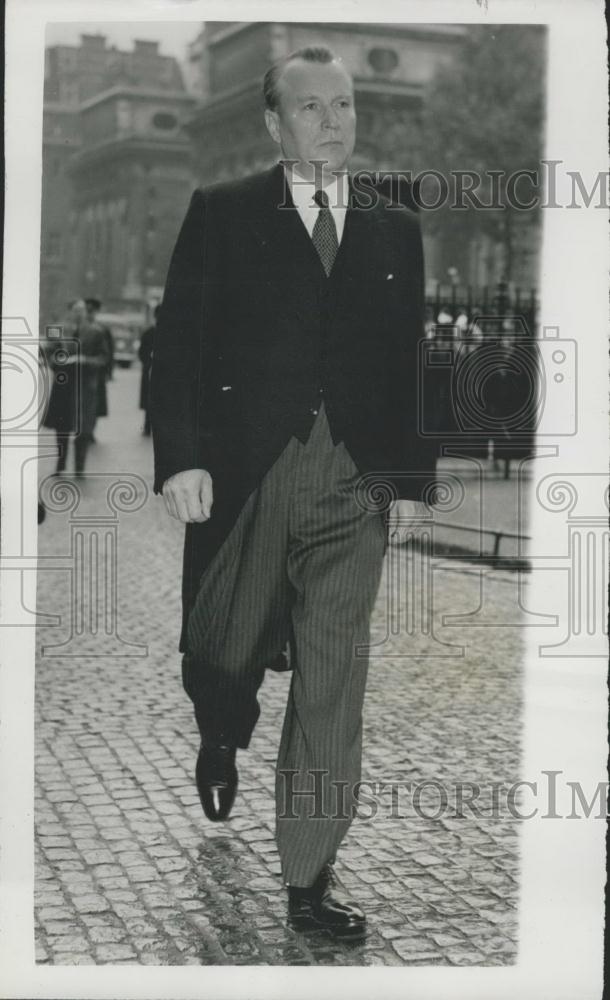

{"left": 0, "top": 0, "right": 609, "bottom": 1000}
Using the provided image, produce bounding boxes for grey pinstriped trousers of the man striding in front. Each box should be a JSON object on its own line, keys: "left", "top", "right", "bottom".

{"left": 183, "top": 407, "right": 386, "bottom": 886}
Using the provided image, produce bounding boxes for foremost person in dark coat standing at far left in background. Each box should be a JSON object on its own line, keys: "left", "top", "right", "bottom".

{"left": 44, "top": 299, "right": 110, "bottom": 475}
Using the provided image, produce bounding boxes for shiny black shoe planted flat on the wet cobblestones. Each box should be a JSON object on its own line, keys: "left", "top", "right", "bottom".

{"left": 288, "top": 864, "right": 366, "bottom": 940}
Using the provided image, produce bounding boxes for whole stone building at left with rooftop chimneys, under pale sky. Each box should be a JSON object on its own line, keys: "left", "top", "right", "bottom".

{"left": 40, "top": 35, "right": 193, "bottom": 326}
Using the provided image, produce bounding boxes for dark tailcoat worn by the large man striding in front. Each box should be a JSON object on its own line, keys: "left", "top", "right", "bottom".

{"left": 151, "top": 165, "right": 436, "bottom": 649}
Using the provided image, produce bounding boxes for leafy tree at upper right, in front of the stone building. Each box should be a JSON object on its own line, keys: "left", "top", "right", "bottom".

{"left": 418, "top": 25, "right": 545, "bottom": 280}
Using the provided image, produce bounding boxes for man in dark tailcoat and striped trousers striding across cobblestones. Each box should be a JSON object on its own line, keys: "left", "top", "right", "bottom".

{"left": 152, "top": 47, "right": 435, "bottom": 937}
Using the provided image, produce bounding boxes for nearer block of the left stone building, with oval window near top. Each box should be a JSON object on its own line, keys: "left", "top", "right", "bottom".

{"left": 68, "top": 86, "right": 193, "bottom": 311}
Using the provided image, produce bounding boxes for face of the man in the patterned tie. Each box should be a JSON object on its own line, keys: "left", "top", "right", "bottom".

{"left": 265, "top": 59, "right": 356, "bottom": 179}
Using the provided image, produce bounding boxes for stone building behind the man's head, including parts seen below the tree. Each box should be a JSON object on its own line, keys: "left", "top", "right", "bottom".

{"left": 185, "top": 21, "right": 539, "bottom": 294}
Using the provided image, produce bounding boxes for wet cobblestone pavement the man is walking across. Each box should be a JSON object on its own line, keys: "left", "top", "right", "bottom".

{"left": 35, "top": 370, "right": 521, "bottom": 965}
